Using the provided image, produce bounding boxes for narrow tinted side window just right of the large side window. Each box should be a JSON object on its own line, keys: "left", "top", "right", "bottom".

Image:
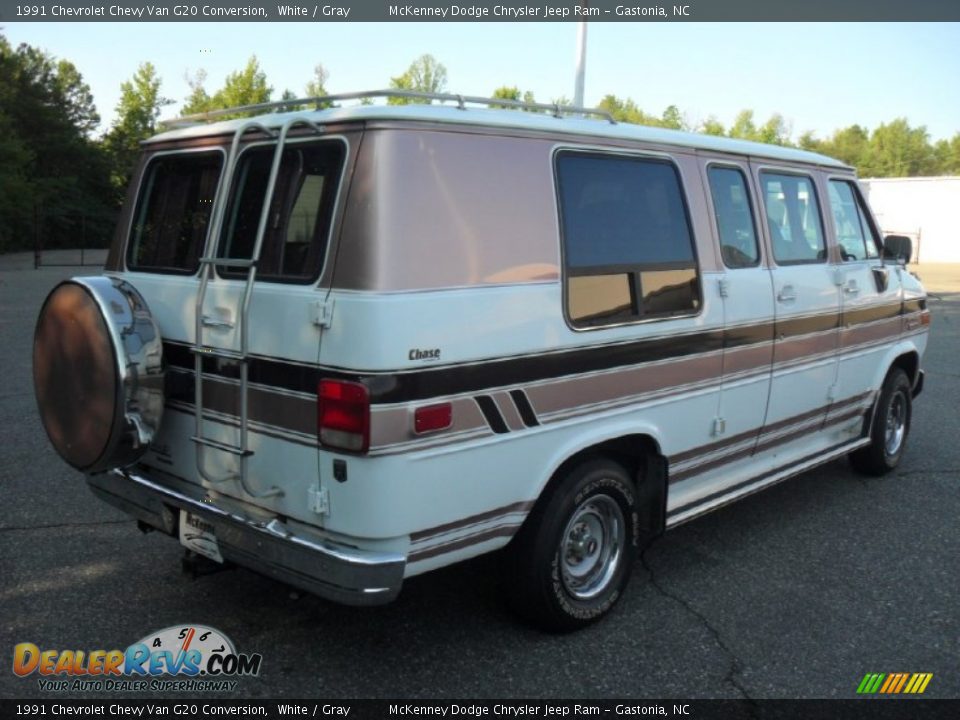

{"left": 707, "top": 167, "right": 760, "bottom": 268}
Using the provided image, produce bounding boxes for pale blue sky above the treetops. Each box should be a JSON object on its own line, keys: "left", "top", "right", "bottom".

{"left": 0, "top": 22, "right": 960, "bottom": 141}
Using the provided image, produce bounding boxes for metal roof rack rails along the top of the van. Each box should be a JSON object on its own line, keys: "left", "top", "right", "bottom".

{"left": 160, "top": 90, "right": 617, "bottom": 127}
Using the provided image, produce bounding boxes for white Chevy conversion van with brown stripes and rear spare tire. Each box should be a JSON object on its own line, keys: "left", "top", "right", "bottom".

{"left": 34, "top": 92, "right": 930, "bottom": 630}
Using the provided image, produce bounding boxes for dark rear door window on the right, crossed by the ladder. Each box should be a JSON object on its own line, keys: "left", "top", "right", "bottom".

{"left": 217, "top": 141, "right": 345, "bottom": 282}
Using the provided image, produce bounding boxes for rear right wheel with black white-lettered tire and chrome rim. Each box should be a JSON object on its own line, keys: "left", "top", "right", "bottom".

{"left": 505, "top": 459, "right": 641, "bottom": 632}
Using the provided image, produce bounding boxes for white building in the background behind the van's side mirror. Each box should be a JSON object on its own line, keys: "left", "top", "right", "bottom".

{"left": 860, "top": 176, "right": 960, "bottom": 263}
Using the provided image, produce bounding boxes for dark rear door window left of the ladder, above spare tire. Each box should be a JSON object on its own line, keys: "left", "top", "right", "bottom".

{"left": 127, "top": 152, "right": 223, "bottom": 274}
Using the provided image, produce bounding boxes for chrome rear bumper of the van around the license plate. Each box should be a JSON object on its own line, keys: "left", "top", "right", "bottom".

{"left": 87, "top": 470, "right": 406, "bottom": 605}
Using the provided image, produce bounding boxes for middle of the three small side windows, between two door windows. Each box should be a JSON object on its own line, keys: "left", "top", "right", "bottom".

{"left": 760, "top": 172, "right": 827, "bottom": 265}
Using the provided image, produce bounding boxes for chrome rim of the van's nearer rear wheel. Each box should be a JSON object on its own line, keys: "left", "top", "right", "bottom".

{"left": 560, "top": 495, "right": 626, "bottom": 600}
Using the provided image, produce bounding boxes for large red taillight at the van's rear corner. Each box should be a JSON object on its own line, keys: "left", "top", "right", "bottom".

{"left": 317, "top": 380, "right": 370, "bottom": 452}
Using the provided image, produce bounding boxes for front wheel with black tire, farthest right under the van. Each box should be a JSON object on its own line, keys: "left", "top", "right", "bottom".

{"left": 850, "top": 367, "right": 913, "bottom": 476}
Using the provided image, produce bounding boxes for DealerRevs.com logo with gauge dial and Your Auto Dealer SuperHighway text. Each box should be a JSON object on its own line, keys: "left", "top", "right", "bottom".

{"left": 13, "top": 625, "right": 263, "bottom": 692}
